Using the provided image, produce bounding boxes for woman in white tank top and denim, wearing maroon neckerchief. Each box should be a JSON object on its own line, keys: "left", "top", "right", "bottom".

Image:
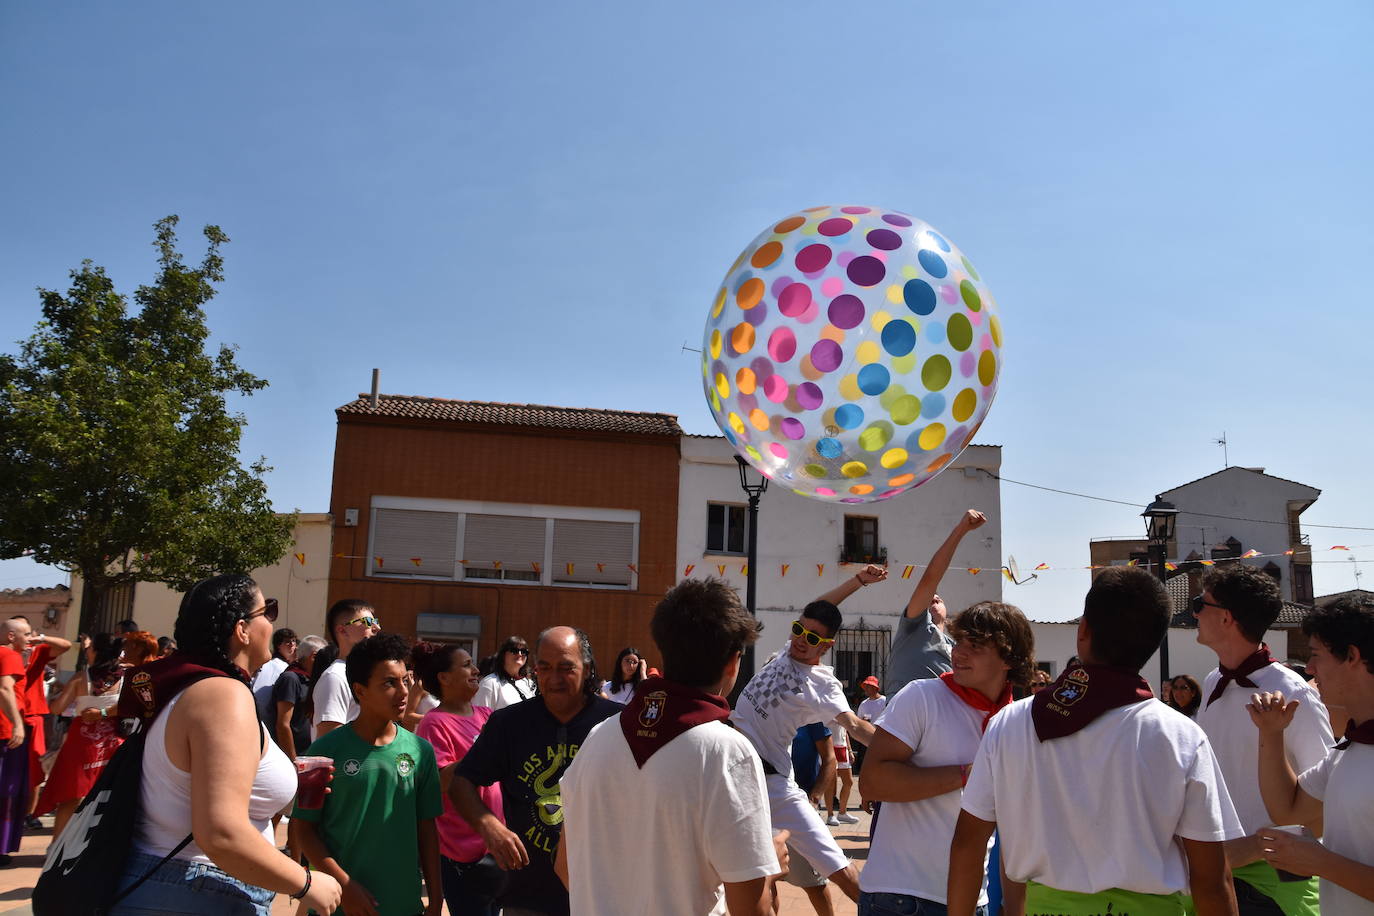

{"left": 109, "top": 575, "right": 341, "bottom": 916}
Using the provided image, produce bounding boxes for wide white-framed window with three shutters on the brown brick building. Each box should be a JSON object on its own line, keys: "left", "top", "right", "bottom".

{"left": 368, "top": 496, "right": 639, "bottom": 588}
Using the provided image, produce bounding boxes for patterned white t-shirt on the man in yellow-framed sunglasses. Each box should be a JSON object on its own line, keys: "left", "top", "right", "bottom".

{"left": 730, "top": 648, "right": 849, "bottom": 776}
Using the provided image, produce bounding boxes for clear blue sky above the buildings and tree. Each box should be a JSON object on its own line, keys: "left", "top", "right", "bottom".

{"left": 0, "top": 0, "right": 1374, "bottom": 619}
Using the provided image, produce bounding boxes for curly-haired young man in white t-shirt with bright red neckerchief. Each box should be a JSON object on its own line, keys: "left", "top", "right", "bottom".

{"left": 859, "top": 602, "right": 1035, "bottom": 915}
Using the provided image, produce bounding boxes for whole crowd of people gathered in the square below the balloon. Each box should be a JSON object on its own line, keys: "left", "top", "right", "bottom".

{"left": 10, "top": 511, "right": 1374, "bottom": 916}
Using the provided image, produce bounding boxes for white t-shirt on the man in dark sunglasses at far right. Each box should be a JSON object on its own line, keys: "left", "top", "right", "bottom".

{"left": 1197, "top": 665, "right": 1336, "bottom": 835}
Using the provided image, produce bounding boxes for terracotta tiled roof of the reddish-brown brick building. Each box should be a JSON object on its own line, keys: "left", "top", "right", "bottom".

{"left": 335, "top": 394, "right": 683, "bottom": 435}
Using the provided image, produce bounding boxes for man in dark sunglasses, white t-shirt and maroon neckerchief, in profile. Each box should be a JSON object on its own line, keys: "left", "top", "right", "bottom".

{"left": 1193, "top": 563, "right": 1334, "bottom": 916}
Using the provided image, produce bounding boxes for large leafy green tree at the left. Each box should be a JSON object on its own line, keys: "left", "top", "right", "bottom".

{"left": 0, "top": 216, "right": 295, "bottom": 619}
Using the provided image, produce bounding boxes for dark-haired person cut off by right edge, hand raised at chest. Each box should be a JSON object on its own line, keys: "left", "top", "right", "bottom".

{"left": 1249, "top": 596, "right": 1374, "bottom": 916}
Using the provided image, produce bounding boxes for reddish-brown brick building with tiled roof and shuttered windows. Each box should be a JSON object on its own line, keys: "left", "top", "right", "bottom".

{"left": 328, "top": 394, "right": 682, "bottom": 669}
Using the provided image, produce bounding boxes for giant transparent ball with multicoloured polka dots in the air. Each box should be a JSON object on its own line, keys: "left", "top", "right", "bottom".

{"left": 701, "top": 206, "right": 1002, "bottom": 503}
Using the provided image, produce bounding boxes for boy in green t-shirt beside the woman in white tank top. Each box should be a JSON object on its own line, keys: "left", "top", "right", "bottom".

{"left": 291, "top": 633, "right": 444, "bottom": 916}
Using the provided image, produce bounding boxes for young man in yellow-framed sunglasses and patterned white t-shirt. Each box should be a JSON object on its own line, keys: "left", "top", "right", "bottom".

{"left": 731, "top": 599, "right": 872, "bottom": 901}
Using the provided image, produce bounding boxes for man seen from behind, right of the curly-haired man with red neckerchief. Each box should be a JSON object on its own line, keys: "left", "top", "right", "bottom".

{"left": 950, "top": 566, "right": 1241, "bottom": 916}
